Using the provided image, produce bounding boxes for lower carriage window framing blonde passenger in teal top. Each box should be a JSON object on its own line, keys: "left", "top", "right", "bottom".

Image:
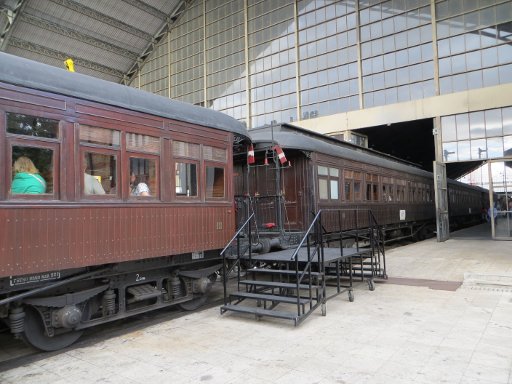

{"left": 11, "top": 146, "right": 53, "bottom": 195}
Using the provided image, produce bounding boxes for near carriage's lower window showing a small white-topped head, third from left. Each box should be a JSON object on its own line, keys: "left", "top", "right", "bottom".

{"left": 129, "top": 157, "right": 158, "bottom": 198}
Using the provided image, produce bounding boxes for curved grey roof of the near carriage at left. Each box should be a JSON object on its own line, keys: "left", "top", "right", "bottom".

{"left": 0, "top": 53, "right": 247, "bottom": 136}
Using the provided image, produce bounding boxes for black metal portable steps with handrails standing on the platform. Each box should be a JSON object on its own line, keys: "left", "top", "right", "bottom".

{"left": 220, "top": 210, "right": 384, "bottom": 325}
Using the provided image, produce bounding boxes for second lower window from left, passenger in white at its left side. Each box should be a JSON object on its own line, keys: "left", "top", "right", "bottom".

{"left": 82, "top": 152, "right": 117, "bottom": 195}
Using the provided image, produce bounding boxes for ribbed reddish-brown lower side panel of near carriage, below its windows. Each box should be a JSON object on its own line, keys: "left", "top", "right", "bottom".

{"left": 0, "top": 205, "right": 234, "bottom": 277}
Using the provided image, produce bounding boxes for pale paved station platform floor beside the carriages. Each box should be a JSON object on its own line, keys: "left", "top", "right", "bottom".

{"left": 0, "top": 224, "right": 512, "bottom": 384}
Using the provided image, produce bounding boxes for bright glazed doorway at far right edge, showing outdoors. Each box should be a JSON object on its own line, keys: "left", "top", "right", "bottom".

{"left": 489, "top": 161, "right": 512, "bottom": 240}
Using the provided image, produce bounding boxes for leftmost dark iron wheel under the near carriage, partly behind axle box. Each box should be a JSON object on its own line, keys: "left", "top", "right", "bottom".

{"left": 23, "top": 306, "right": 83, "bottom": 351}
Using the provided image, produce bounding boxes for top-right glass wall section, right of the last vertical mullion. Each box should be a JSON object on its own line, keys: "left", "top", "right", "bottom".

{"left": 436, "top": 0, "right": 512, "bottom": 93}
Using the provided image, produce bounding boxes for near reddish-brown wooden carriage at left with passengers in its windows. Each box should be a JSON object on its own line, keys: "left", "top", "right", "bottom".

{"left": 0, "top": 54, "right": 247, "bottom": 350}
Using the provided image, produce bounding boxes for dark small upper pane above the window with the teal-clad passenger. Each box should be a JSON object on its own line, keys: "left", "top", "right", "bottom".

{"left": 7, "top": 113, "right": 59, "bottom": 139}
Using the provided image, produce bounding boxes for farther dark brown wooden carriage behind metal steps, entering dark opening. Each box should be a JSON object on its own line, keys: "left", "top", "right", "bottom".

{"left": 235, "top": 124, "right": 486, "bottom": 251}
